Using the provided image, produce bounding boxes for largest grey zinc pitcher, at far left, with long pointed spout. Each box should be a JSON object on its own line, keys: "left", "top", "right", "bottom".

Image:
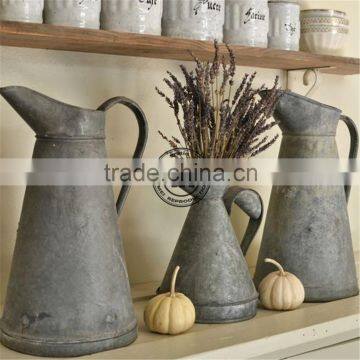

{"left": 0, "top": 87, "right": 147, "bottom": 357}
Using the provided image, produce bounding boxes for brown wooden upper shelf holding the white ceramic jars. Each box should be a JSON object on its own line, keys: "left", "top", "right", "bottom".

{"left": 0, "top": 21, "right": 360, "bottom": 75}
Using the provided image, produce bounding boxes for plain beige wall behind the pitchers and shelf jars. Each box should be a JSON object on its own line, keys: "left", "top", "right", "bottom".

{"left": 0, "top": 1, "right": 360, "bottom": 303}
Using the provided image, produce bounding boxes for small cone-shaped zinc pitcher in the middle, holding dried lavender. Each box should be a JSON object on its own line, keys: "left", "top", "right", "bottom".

{"left": 158, "top": 185, "right": 262, "bottom": 323}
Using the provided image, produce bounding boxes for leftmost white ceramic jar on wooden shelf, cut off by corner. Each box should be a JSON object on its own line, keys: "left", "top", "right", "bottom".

{"left": 0, "top": 0, "right": 44, "bottom": 24}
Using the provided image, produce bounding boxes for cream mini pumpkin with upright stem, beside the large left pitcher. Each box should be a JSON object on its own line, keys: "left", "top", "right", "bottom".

{"left": 144, "top": 266, "right": 195, "bottom": 335}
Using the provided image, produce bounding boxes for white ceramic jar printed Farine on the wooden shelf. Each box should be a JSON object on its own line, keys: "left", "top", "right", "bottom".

{"left": 224, "top": 0, "right": 269, "bottom": 47}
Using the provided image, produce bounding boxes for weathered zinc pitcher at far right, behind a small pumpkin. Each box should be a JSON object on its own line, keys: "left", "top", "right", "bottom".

{"left": 254, "top": 91, "right": 359, "bottom": 302}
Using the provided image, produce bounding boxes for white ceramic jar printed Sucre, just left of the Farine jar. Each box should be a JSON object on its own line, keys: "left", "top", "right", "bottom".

{"left": 162, "top": 0, "right": 225, "bottom": 41}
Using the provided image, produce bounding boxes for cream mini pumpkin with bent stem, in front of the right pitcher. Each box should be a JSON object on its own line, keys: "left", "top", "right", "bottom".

{"left": 259, "top": 259, "right": 305, "bottom": 310}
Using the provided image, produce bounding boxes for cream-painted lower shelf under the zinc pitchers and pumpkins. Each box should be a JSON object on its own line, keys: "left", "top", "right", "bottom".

{"left": 0, "top": 254, "right": 360, "bottom": 360}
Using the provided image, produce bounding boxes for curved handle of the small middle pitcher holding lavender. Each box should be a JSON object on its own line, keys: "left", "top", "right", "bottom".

{"left": 223, "top": 186, "right": 263, "bottom": 256}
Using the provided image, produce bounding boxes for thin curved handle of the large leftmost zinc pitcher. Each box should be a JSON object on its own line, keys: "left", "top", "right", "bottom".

{"left": 98, "top": 96, "right": 148, "bottom": 215}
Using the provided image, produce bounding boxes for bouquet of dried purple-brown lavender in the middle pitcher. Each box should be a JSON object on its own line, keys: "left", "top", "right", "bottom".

{"left": 156, "top": 42, "right": 280, "bottom": 158}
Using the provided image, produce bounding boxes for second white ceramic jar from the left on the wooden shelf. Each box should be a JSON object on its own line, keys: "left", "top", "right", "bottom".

{"left": 44, "top": 0, "right": 101, "bottom": 29}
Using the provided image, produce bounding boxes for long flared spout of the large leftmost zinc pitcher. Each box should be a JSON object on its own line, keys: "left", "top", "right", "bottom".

{"left": 0, "top": 86, "right": 104, "bottom": 137}
